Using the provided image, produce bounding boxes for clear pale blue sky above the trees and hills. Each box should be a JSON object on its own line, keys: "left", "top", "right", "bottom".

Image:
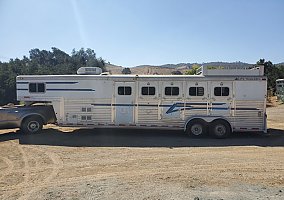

{"left": 0, "top": 0, "right": 284, "bottom": 67}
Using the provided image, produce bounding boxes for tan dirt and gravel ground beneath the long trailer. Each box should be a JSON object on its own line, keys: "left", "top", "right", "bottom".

{"left": 0, "top": 101, "right": 284, "bottom": 200}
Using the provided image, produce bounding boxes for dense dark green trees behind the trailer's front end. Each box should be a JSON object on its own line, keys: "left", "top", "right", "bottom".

{"left": 0, "top": 47, "right": 106, "bottom": 105}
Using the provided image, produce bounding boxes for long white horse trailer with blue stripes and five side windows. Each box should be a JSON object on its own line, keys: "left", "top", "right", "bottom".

{"left": 17, "top": 66, "right": 267, "bottom": 138}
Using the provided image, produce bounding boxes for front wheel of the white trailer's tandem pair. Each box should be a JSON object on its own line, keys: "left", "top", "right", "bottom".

{"left": 186, "top": 119, "right": 207, "bottom": 137}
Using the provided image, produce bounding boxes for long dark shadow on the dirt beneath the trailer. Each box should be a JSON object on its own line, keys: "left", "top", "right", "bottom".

{"left": 0, "top": 128, "right": 284, "bottom": 148}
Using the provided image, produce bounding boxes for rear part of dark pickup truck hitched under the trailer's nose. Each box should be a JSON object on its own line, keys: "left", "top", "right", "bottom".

{"left": 0, "top": 105, "right": 56, "bottom": 133}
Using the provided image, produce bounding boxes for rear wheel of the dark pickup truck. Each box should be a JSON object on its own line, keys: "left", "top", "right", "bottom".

{"left": 21, "top": 116, "right": 43, "bottom": 134}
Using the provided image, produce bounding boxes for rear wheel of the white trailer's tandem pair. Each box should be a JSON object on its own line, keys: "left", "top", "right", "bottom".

{"left": 210, "top": 120, "right": 232, "bottom": 139}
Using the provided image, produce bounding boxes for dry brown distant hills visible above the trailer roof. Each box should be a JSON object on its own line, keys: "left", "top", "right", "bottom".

{"left": 106, "top": 62, "right": 253, "bottom": 75}
